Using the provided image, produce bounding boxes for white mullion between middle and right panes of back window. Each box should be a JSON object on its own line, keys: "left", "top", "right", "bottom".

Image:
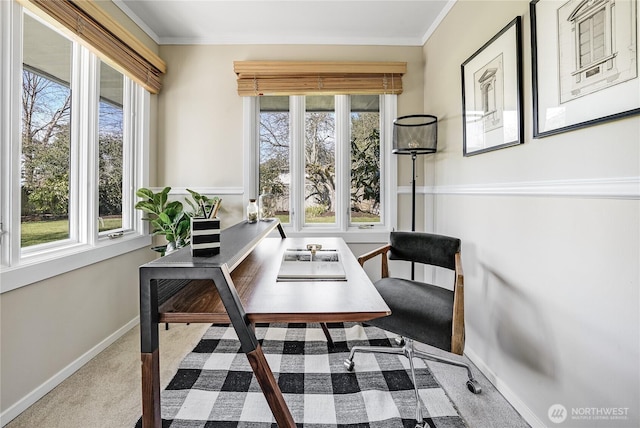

{"left": 335, "top": 95, "right": 351, "bottom": 232}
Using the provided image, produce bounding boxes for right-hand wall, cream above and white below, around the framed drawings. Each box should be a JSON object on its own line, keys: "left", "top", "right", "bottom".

{"left": 424, "top": 0, "right": 640, "bottom": 427}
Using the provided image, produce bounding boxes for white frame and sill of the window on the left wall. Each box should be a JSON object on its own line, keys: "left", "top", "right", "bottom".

{"left": 0, "top": 1, "right": 152, "bottom": 293}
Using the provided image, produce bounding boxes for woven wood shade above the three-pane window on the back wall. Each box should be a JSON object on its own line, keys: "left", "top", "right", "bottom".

{"left": 233, "top": 61, "right": 407, "bottom": 96}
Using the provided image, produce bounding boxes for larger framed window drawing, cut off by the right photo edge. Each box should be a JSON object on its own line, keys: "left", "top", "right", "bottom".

{"left": 529, "top": 0, "right": 640, "bottom": 138}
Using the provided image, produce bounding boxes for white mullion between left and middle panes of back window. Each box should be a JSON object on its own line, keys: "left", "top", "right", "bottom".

{"left": 289, "top": 96, "right": 305, "bottom": 232}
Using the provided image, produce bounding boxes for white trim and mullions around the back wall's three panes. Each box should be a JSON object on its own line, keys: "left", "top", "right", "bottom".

{"left": 243, "top": 95, "right": 397, "bottom": 243}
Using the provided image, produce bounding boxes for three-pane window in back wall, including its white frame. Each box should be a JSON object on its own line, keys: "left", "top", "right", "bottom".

{"left": 250, "top": 95, "right": 396, "bottom": 239}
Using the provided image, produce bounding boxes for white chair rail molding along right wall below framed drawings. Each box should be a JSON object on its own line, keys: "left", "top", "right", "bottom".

{"left": 398, "top": 177, "right": 640, "bottom": 200}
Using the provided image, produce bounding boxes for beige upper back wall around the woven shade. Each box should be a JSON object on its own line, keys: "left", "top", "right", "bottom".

{"left": 156, "top": 45, "right": 424, "bottom": 227}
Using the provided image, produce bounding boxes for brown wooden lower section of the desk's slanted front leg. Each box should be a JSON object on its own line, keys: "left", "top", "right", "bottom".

{"left": 247, "top": 345, "right": 296, "bottom": 428}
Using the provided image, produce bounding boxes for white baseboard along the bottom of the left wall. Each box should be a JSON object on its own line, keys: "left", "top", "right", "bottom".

{"left": 0, "top": 316, "right": 140, "bottom": 426}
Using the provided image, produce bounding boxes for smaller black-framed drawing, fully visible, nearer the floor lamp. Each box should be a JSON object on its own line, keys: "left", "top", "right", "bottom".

{"left": 461, "top": 16, "right": 524, "bottom": 156}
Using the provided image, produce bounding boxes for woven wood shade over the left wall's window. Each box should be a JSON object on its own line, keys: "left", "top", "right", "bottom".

{"left": 18, "top": 0, "right": 167, "bottom": 94}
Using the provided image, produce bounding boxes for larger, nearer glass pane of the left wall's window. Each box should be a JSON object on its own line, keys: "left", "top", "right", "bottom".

{"left": 20, "top": 15, "right": 73, "bottom": 248}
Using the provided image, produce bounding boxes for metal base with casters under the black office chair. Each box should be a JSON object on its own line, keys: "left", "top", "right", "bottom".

{"left": 344, "top": 338, "right": 482, "bottom": 428}
